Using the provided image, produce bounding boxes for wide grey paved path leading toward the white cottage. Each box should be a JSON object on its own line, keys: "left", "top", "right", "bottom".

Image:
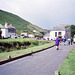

{"left": 0, "top": 44, "right": 74, "bottom": 75}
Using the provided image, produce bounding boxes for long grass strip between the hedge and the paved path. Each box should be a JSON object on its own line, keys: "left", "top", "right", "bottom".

{"left": 0, "top": 42, "right": 54, "bottom": 62}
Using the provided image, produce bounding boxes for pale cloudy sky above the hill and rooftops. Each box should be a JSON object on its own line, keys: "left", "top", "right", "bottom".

{"left": 0, "top": 0, "right": 75, "bottom": 29}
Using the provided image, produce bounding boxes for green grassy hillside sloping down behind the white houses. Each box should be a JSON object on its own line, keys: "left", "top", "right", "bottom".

{"left": 0, "top": 10, "right": 46, "bottom": 34}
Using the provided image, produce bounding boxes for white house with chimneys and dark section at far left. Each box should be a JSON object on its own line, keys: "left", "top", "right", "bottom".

{"left": 0, "top": 23, "right": 16, "bottom": 38}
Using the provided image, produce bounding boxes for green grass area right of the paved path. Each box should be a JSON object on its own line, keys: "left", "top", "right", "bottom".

{"left": 59, "top": 47, "right": 75, "bottom": 75}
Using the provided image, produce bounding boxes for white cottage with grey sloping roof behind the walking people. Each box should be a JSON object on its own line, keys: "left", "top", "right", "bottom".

{"left": 50, "top": 24, "right": 66, "bottom": 40}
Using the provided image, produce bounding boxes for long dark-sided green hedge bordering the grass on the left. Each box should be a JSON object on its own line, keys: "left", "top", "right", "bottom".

{"left": 0, "top": 39, "right": 49, "bottom": 52}
